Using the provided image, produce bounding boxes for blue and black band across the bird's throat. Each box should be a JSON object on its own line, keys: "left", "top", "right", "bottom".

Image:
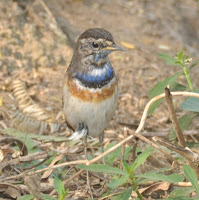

{"left": 75, "top": 63, "right": 115, "bottom": 88}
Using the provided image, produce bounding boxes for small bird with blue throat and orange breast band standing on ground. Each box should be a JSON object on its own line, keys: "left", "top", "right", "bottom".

{"left": 63, "top": 28, "right": 122, "bottom": 198}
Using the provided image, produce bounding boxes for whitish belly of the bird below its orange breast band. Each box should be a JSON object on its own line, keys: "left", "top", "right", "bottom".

{"left": 63, "top": 77, "right": 118, "bottom": 137}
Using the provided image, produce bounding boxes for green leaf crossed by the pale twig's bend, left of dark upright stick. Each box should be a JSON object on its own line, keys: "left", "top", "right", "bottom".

{"left": 149, "top": 72, "right": 183, "bottom": 115}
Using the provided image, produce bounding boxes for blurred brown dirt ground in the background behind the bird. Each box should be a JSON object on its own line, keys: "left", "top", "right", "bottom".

{"left": 0, "top": 0, "right": 199, "bottom": 199}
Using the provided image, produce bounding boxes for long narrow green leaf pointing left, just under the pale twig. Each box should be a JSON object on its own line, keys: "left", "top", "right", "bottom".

{"left": 78, "top": 164, "right": 126, "bottom": 175}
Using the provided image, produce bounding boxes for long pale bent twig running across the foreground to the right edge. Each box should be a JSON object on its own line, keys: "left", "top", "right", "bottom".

{"left": 0, "top": 92, "right": 199, "bottom": 181}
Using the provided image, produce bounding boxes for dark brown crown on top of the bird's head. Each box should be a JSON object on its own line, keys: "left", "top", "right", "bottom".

{"left": 79, "top": 28, "right": 113, "bottom": 42}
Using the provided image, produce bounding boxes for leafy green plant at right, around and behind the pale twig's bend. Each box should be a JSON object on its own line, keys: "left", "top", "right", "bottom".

{"left": 149, "top": 52, "right": 199, "bottom": 139}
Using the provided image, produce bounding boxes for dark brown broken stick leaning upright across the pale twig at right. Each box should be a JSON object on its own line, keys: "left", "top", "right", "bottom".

{"left": 164, "top": 87, "right": 186, "bottom": 148}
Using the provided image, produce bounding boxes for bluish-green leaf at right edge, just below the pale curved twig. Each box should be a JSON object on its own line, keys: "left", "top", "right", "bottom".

{"left": 180, "top": 90, "right": 199, "bottom": 112}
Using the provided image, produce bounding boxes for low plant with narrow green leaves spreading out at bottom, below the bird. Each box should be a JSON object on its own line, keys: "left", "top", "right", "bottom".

{"left": 79, "top": 145, "right": 184, "bottom": 200}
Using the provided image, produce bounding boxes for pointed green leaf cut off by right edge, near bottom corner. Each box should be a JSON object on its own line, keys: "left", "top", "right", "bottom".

{"left": 183, "top": 164, "right": 199, "bottom": 194}
